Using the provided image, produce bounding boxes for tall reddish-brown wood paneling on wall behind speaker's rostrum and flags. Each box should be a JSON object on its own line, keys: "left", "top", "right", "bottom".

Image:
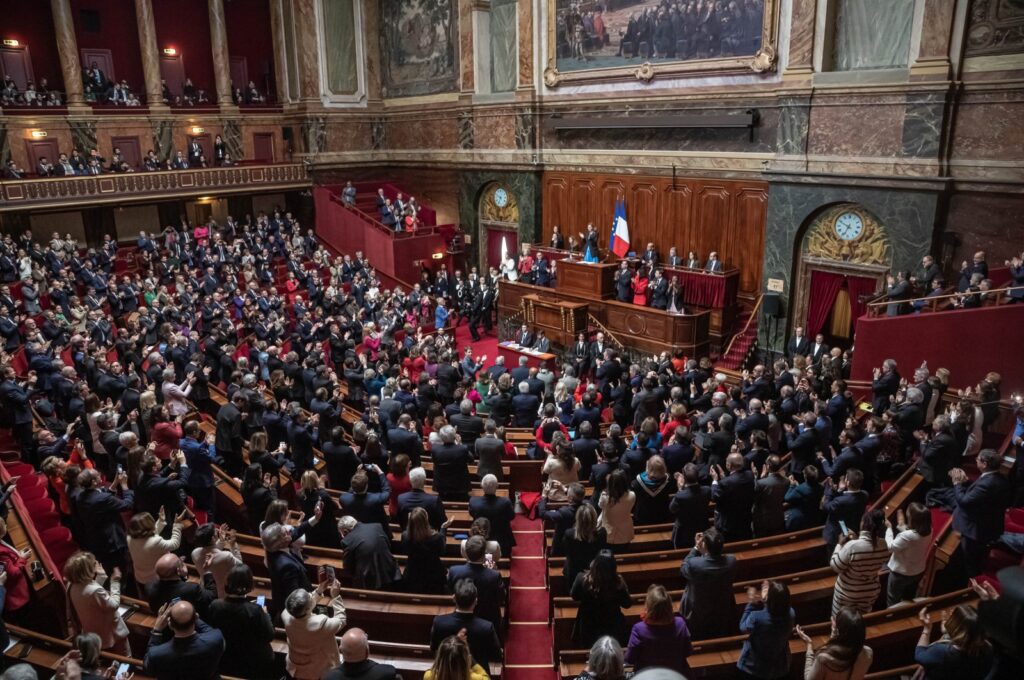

{"left": 541, "top": 172, "right": 768, "bottom": 299}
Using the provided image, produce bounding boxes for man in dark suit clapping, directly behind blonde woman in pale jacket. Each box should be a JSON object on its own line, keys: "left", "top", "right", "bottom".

{"left": 72, "top": 470, "right": 135, "bottom": 573}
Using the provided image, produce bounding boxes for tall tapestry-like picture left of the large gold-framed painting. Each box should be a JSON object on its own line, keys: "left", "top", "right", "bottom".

{"left": 380, "top": 0, "right": 459, "bottom": 97}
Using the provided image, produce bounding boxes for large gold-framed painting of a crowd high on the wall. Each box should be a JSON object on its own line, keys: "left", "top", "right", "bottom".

{"left": 544, "top": 0, "right": 779, "bottom": 87}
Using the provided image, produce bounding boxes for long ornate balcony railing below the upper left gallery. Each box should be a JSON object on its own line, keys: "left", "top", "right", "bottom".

{"left": 0, "top": 163, "right": 311, "bottom": 212}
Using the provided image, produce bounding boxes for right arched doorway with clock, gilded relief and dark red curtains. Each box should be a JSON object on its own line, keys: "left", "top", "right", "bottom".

{"left": 791, "top": 203, "right": 893, "bottom": 347}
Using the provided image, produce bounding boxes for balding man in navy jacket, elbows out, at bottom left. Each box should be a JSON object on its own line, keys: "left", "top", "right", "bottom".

{"left": 142, "top": 600, "right": 224, "bottom": 680}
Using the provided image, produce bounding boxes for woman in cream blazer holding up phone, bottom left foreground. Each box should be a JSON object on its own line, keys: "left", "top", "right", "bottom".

{"left": 281, "top": 581, "right": 345, "bottom": 680}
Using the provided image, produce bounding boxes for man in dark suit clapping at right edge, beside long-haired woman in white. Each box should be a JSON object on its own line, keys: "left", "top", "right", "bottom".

{"left": 949, "top": 449, "right": 1014, "bottom": 577}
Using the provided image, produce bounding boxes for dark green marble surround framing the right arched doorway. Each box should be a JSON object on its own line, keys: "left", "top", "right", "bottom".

{"left": 759, "top": 179, "right": 939, "bottom": 350}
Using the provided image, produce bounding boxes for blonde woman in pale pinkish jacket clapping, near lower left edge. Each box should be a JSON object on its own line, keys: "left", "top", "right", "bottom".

{"left": 63, "top": 551, "right": 131, "bottom": 656}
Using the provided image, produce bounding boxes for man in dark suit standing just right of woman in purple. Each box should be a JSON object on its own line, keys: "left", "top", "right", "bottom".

{"left": 679, "top": 526, "right": 736, "bottom": 640}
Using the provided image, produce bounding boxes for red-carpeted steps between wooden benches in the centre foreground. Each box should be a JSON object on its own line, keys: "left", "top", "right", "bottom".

{"left": 503, "top": 515, "right": 558, "bottom": 680}
